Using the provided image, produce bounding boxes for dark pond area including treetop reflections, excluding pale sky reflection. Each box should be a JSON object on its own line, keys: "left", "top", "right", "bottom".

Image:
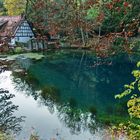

{"left": 10, "top": 52, "right": 139, "bottom": 134}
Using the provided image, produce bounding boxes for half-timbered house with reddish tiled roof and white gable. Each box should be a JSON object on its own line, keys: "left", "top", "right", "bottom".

{"left": 0, "top": 16, "right": 35, "bottom": 45}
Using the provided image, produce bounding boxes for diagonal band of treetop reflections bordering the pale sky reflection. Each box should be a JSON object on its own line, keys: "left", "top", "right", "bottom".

{"left": 13, "top": 72, "right": 98, "bottom": 134}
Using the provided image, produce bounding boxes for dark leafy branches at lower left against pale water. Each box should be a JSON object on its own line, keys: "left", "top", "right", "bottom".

{"left": 0, "top": 89, "right": 25, "bottom": 134}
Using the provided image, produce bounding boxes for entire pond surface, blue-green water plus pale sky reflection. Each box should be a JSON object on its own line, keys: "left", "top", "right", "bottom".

{"left": 0, "top": 51, "right": 137, "bottom": 140}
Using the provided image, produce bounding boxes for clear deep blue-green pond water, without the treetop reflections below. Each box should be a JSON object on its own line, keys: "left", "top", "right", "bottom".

{"left": 29, "top": 52, "right": 135, "bottom": 113}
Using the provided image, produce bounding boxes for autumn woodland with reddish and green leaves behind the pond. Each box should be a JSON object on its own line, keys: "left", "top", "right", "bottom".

{"left": 27, "top": 0, "right": 140, "bottom": 57}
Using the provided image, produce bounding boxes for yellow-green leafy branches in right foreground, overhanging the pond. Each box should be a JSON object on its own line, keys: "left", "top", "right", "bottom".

{"left": 112, "top": 62, "right": 140, "bottom": 140}
